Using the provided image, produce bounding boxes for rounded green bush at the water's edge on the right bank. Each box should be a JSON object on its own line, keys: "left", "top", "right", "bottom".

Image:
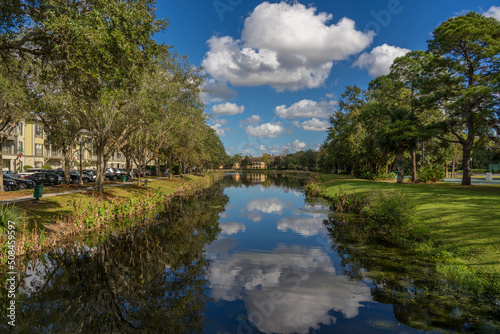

{"left": 362, "top": 192, "right": 415, "bottom": 246}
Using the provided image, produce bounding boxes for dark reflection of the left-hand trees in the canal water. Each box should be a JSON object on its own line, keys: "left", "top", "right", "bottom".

{"left": 14, "top": 184, "right": 228, "bottom": 333}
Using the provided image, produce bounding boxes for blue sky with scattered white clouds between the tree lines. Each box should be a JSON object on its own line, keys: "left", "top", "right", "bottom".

{"left": 155, "top": 0, "right": 500, "bottom": 157}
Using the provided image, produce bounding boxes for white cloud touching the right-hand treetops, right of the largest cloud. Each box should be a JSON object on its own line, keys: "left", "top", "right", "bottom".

{"left": 353, "top": 44, "right": 411, "bottom": 77}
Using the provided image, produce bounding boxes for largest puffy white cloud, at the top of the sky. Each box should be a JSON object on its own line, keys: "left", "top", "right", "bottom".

{"left": 203, "top": 2, "right": 374, "bottom": 91}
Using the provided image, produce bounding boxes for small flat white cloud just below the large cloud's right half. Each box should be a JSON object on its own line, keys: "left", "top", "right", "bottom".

{"left": 275, "top": 100, "right": 338, "bottom": 119}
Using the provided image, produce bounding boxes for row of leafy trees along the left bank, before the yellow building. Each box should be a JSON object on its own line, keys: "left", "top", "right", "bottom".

{"left": 0, "top": 0, "right": 227, "bottom": 192}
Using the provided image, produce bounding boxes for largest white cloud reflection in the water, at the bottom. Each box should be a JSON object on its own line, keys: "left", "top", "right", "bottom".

{"left": 207, "top": 243, "right": 373, "bottom": 333}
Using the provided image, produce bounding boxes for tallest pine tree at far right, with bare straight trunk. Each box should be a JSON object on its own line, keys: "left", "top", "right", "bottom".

{"left": 424, "top": 12, "right": 500, "bottom": 185}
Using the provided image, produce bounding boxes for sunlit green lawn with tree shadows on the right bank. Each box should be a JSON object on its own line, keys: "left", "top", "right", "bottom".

{"left": 321, "top": 174, "right": 500, "bottom": 274}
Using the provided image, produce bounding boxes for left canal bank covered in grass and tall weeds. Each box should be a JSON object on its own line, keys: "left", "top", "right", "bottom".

{"left": 0, "top": 172, "right": 223, "bottom": 277}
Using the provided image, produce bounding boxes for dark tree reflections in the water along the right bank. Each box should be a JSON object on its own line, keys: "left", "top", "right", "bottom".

{"left": 324, "top": 215, "right": 500, "bottom": 333}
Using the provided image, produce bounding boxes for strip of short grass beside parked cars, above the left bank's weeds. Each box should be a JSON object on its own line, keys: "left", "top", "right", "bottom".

{"left": 16, "top": 175, "right": 199, "bottom": 225}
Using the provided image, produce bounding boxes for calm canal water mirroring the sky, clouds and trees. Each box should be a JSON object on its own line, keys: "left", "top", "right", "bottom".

{"left": 0, "top": 174, "right": 500, "bottom": 334}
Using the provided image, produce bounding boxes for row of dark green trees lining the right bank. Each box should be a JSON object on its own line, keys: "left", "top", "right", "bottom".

{"left": 320, "top": 12, "right": 500, "bottom": 185}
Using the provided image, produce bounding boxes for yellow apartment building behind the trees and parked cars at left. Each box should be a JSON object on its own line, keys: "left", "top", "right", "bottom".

{"left": 2, "top": 121, "right": 126, "bottom": 171}
